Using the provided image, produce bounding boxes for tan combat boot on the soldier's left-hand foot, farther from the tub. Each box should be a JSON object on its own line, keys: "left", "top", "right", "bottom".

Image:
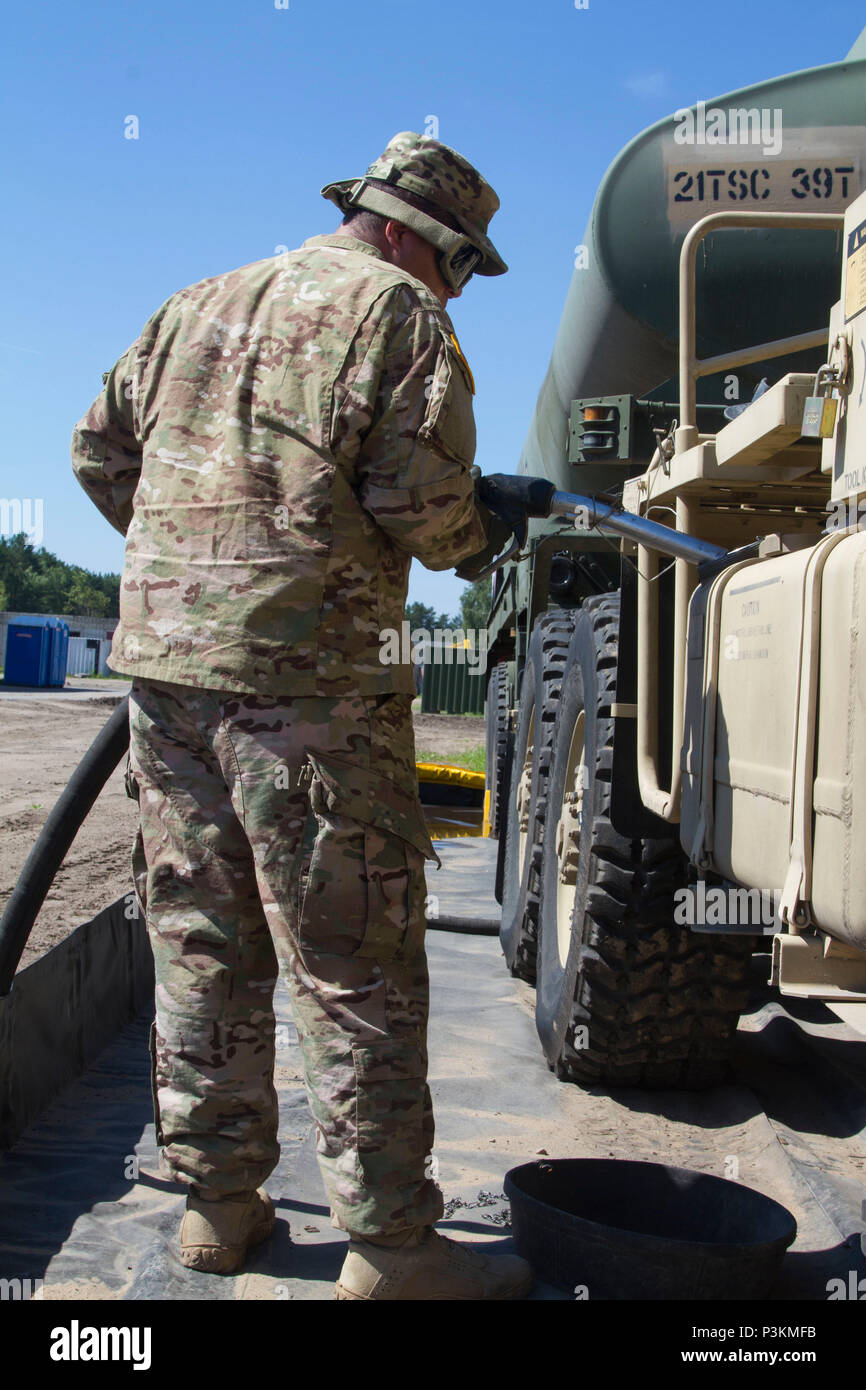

{"left": 181, "top": 1187, "right": 274, "bottom": 1275}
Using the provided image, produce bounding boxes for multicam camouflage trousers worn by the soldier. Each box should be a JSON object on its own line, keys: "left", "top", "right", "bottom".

{"left": 128, "top": 680, "right": 442, "bottom": 1236}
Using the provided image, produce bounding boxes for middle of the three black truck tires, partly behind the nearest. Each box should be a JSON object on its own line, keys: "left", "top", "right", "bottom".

{"left": 499, "top": 609, "right": 574, "bottom": 984}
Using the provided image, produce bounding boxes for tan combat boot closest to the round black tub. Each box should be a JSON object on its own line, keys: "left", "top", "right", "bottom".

{"left": 334, "top": 1226, "right": 532, "bottom": 1302}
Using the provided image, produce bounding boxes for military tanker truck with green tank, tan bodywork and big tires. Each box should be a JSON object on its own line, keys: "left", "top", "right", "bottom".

{"left": 487, "top": 31, "right": 866, "bottom": 1087}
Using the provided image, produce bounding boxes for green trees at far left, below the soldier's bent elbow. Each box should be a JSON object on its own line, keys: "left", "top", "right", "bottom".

{"left": 0, "top": 531, "right": 121, "bottom": 617}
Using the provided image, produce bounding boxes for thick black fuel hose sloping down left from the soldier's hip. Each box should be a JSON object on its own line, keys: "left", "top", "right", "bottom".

{"left": 0, "top": 696, "right": 129, "bottom": 995}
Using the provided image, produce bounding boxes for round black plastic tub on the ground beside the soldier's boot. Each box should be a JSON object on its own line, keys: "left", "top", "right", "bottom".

{"left": 505, "top": 1158, "right": 796, "bottom": 1300}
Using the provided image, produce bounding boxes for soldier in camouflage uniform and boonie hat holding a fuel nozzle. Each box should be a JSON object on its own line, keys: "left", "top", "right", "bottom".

{"left": 72, "top": 132, "right": 531, "bottom": 1300}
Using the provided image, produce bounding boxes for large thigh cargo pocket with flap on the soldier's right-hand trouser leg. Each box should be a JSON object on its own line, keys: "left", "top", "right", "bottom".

{"left": 297, "top": 749, "right": 439, "bottom": 960}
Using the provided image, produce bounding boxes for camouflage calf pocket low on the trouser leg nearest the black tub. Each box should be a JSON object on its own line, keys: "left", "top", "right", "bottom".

{"left": 349, "top": 1038, "right": 442, "bottom": 1234}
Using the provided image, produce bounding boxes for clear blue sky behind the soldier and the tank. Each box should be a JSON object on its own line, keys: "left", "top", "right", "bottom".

{"left": 0, "top": 0, "right": 865, "bottom": 612}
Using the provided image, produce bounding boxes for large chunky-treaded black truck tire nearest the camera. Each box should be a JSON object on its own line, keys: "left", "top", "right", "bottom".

{"left": 535, "top": 595, "right": 755, "bottom": 1090}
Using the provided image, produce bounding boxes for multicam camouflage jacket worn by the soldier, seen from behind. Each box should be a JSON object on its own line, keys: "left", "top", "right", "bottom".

{"left": 72, "top": 234, "right": 487, "bottom": 696}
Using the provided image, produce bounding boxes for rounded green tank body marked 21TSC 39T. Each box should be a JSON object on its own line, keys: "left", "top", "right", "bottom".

{"left": 518, "top": 31, "right": 866, "bottom": 491}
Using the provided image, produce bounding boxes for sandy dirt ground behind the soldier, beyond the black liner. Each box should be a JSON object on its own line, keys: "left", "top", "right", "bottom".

{"left": 0, "top": 694, "right": 484, "bottom": 969}
